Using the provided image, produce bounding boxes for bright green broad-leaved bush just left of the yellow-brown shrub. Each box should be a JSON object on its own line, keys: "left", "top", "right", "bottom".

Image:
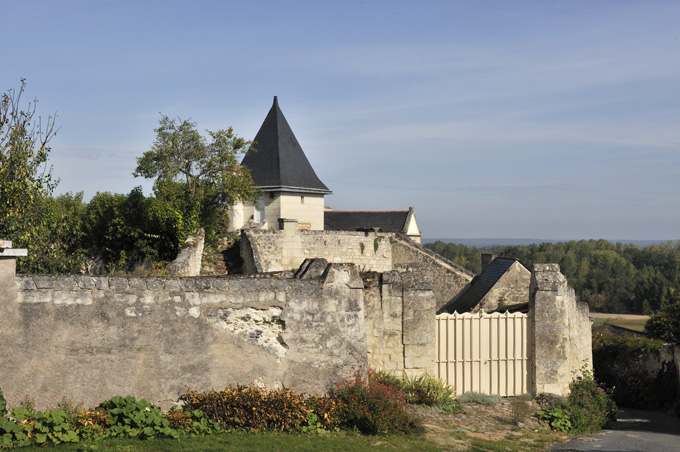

{"left": 98, "top": 396, "right": 179, "bottom": 439}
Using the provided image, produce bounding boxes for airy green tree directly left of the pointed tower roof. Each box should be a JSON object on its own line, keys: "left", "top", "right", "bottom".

{"left": 133, "top": 114, "right": 259, "bottom": 236}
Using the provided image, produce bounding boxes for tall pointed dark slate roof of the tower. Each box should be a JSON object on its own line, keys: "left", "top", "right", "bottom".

{"left": 241, "top": 96, "right": 331, "bottom": 194}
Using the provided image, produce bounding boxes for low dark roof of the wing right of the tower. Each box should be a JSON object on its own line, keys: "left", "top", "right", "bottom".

{"left": 323, "top": 210, "right": 408, "bottom": 232}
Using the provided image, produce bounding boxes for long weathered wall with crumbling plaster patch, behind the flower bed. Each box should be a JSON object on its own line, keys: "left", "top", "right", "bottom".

{"left": 0, "top": 260, "right": 367, "bottom": 408}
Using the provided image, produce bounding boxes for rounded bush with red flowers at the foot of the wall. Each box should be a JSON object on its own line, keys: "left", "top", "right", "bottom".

{"left": 331, "top": 369, "right": 413, "bottom": 435}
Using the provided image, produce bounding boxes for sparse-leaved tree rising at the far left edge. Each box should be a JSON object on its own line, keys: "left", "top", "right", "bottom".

{"left": 0, "top": 78, "right": 58, "bottom": 253}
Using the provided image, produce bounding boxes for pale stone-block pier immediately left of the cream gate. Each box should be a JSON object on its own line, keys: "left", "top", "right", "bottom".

{"left": 364, "top": 271, "right": 436, "bottom": 376}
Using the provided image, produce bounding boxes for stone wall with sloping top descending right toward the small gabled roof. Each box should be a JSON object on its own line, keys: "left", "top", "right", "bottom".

{"left": 392, "top": 236, "right": 475, "bottom": 309}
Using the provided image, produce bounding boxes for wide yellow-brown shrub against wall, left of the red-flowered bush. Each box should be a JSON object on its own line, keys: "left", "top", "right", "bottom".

{"left": 180, "top": 385, "right": 309, "bottom": 431}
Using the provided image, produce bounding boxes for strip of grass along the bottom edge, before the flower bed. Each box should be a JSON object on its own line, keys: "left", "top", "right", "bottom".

{"left": 16, "top": 432, "right": 557, "bottom": 452}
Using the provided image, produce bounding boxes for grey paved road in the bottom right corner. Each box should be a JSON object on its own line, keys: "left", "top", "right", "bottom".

{"left": 548, "top": 408, "right": 680, "bottom": 452}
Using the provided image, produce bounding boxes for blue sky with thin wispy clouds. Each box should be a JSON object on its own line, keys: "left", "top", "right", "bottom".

{"left": 0, "top": 0, "right": 680, "bottom": 240}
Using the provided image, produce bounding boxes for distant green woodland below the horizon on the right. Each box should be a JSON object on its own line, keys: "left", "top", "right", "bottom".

{"left": 425, "top": 240, "right": 680, "bottom": 314}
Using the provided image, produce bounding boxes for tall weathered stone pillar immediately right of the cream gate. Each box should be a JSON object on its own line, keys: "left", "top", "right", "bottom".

{"left": 529, "top": 264, "right": 593, "bottom": 395}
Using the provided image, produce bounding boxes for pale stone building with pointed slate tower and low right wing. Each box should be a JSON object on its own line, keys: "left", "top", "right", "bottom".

{"left": 229, "top": 96, "right": 421, "bottom": 238}
